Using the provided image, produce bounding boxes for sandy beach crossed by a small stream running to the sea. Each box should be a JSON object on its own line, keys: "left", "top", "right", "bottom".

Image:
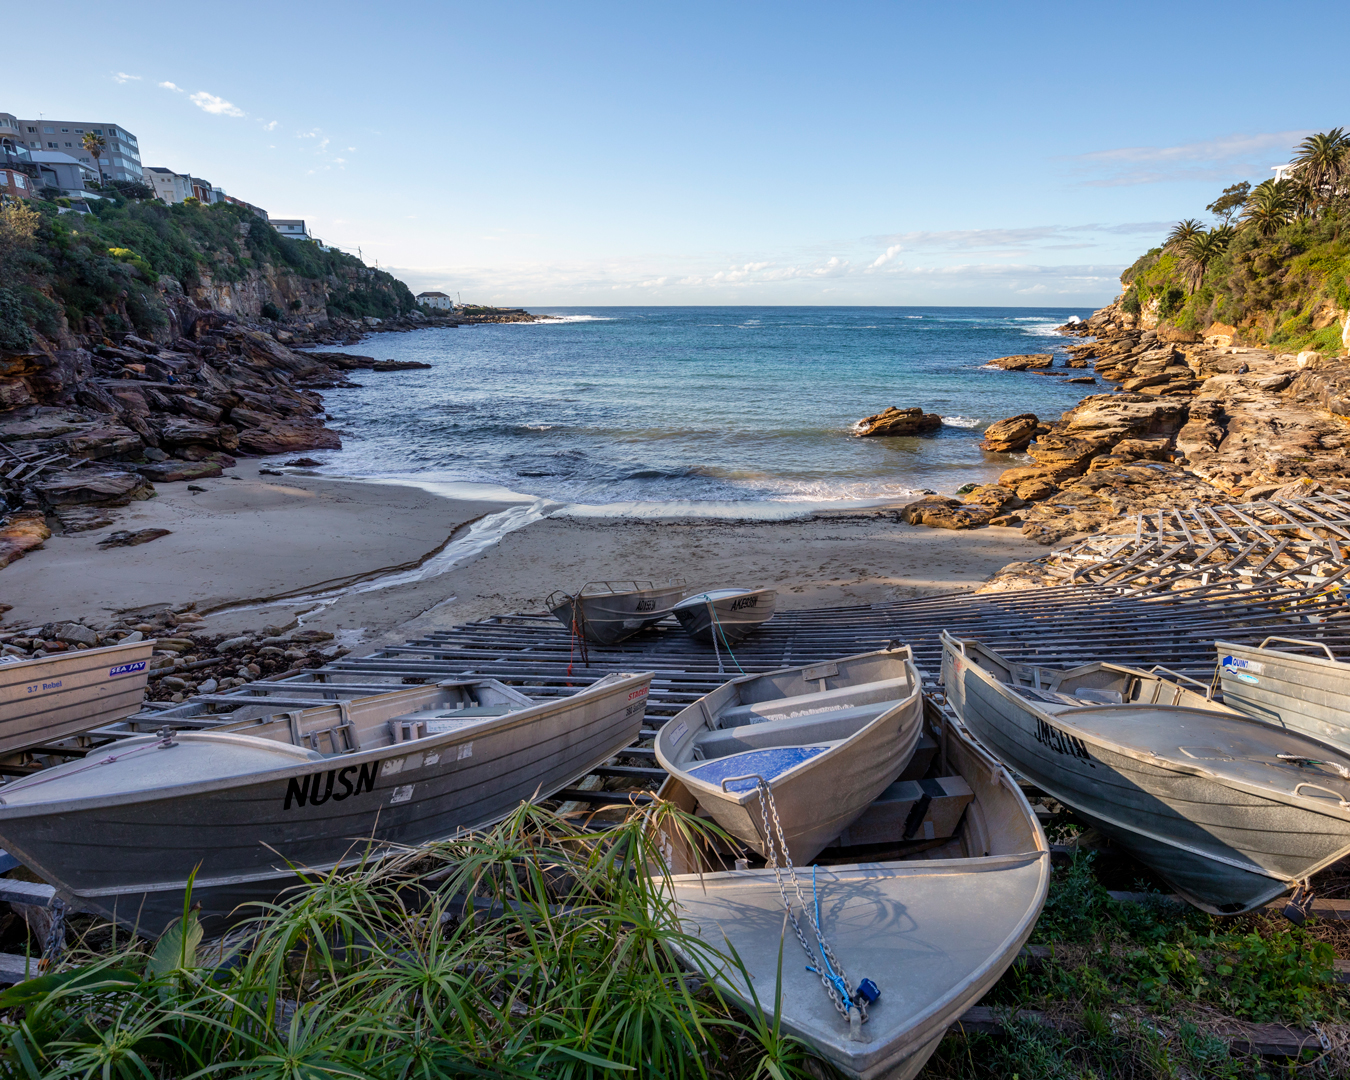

{"left": 0, "top": 460, "right": 1044, "bottom": 647}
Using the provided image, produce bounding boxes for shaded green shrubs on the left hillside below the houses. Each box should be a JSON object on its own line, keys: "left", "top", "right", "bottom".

{"left": 0, "top": 188, "right": 414, "bottom": 348}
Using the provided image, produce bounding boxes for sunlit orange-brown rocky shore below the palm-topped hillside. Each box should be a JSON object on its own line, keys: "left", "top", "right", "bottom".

{"left": 902, "top": 295, "right": 1350, "bottom": 544}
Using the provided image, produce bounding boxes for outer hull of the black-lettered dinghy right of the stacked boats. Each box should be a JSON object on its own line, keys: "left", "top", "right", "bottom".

{"left": 942, "top": 640, "right": 1350, "bottom": 914}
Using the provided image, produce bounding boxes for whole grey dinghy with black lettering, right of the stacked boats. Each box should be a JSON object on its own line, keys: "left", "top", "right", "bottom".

{"left": 942, "top": 635, "right": 1350, "bottom": 915}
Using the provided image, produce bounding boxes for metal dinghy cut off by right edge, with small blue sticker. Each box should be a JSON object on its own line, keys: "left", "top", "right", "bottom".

{"left": 1215, "top": 637, "right": 1350, "bottom": 751}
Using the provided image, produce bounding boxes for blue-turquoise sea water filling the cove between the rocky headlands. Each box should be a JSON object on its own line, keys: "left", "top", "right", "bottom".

{"left": 315, "top": 308, "right": 1107, "bottom": 505}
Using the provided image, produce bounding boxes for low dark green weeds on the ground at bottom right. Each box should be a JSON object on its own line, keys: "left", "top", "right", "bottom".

{"left": 923, "top": 852, "right": 1350, "bottom": 1080}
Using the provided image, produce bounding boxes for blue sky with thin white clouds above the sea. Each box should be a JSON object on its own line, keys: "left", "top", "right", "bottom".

{"left": 10, "top": 0, "right": 1350, "bottom": 306}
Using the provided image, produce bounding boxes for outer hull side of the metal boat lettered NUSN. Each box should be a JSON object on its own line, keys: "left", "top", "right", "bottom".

{"left": 0, "top": 675, "right": 651, "bottom": 934}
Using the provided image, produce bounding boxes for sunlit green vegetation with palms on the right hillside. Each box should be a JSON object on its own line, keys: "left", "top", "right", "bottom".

{"left": 1121, "top": 128, "right": 1350, "bottom": 352}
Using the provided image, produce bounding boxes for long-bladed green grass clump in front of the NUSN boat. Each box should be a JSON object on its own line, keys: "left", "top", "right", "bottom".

{"left": 0, "top": 805, "right": 806, "bottom": 1080}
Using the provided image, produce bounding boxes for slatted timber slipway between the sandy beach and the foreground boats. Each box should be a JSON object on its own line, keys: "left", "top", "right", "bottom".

{"left": 124, "top": 493, "right": 1350, "bottom": 803}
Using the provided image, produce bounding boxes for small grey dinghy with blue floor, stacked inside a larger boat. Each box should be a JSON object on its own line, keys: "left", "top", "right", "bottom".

{"left": 656, "top": 647, "right": 923, "bottom": 864}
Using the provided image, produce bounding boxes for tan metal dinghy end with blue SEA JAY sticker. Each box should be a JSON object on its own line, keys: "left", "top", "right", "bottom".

{"left": 0, "top": 641, "right": 155, "bottom": 753}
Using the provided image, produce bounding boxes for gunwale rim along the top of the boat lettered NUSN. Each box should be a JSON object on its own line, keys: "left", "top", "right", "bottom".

{"left": 0, "top": 671, "right": 652, "bottom": 822}
